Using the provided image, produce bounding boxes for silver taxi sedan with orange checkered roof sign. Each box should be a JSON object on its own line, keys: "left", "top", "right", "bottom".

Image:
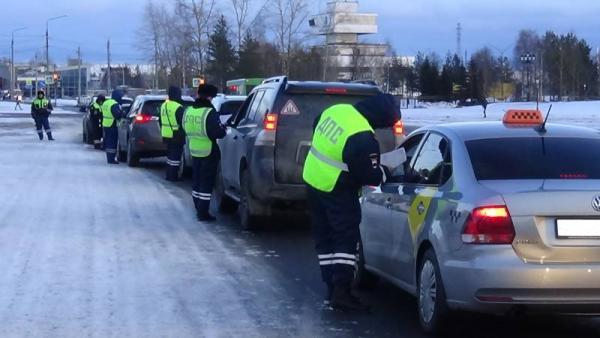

{"left": 356, "top": 111, "right": 600, "bottom": 332}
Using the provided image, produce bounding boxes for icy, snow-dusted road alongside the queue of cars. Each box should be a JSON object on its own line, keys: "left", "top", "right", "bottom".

{"left": 0, "top": 113, "right": 600, "bottom": 338}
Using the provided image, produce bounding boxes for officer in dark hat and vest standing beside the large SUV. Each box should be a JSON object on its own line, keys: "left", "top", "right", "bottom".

{"left": 183, "top": 84, "right": 227, "bottom": 221}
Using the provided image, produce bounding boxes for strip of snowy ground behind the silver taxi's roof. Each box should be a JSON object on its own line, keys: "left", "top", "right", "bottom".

{"left": 402, "top": 101, "right": 600, "bottom": 129}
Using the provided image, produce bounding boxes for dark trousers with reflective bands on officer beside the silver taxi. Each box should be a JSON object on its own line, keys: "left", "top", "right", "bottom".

{"left": 308, "top": 187, "right": 361, "bottom": 288}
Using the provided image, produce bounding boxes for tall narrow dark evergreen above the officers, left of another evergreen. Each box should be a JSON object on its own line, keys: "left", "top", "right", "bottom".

{"left": 208, "top": 15, "right": 237, "bottom": 88}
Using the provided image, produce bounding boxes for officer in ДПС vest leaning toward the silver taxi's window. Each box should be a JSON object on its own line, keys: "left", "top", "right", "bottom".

{"left": 303, "top": 94, "right": 400, "bottom": 311}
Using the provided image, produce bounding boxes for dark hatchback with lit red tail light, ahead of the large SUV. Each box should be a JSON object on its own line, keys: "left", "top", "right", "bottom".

{"left": 117, "top": 95, "right": 193, "bottom": 167}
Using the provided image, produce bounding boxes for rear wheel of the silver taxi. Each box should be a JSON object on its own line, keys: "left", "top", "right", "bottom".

{"left": 417, "top": 249, "right": 449, "bottom": 334}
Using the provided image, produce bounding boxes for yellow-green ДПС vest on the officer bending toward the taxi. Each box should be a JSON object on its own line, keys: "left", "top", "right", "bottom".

{"left": 302, "top": 104, "right": 374, "bottom": 192}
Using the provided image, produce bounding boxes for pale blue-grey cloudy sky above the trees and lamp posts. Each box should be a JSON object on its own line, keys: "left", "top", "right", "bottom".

{"left": 0, "top": 0, "right": 600, "bottom": 63}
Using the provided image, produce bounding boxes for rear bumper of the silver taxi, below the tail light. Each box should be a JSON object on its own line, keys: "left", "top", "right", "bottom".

{"left": 440, "top": 246, "right": 600, "bottom": 313}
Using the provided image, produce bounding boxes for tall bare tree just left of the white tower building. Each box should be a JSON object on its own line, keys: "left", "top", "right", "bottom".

{"left": 273, "top": 0, "right": 308, "bottom": 74}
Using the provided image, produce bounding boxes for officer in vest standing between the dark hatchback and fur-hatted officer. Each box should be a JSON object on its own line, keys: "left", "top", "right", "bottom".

{"left": 160, "top": 86, "right": 185, "bottom": 181}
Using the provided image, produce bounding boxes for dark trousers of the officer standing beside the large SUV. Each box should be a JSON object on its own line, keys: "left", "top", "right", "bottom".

{"left": 192, "top": 144, "right": 221, "bottom": 215}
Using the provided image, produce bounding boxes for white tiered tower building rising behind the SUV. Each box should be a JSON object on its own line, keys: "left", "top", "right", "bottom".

{"left": 309, "top": 0, "right": 389, "bottom": 83}
